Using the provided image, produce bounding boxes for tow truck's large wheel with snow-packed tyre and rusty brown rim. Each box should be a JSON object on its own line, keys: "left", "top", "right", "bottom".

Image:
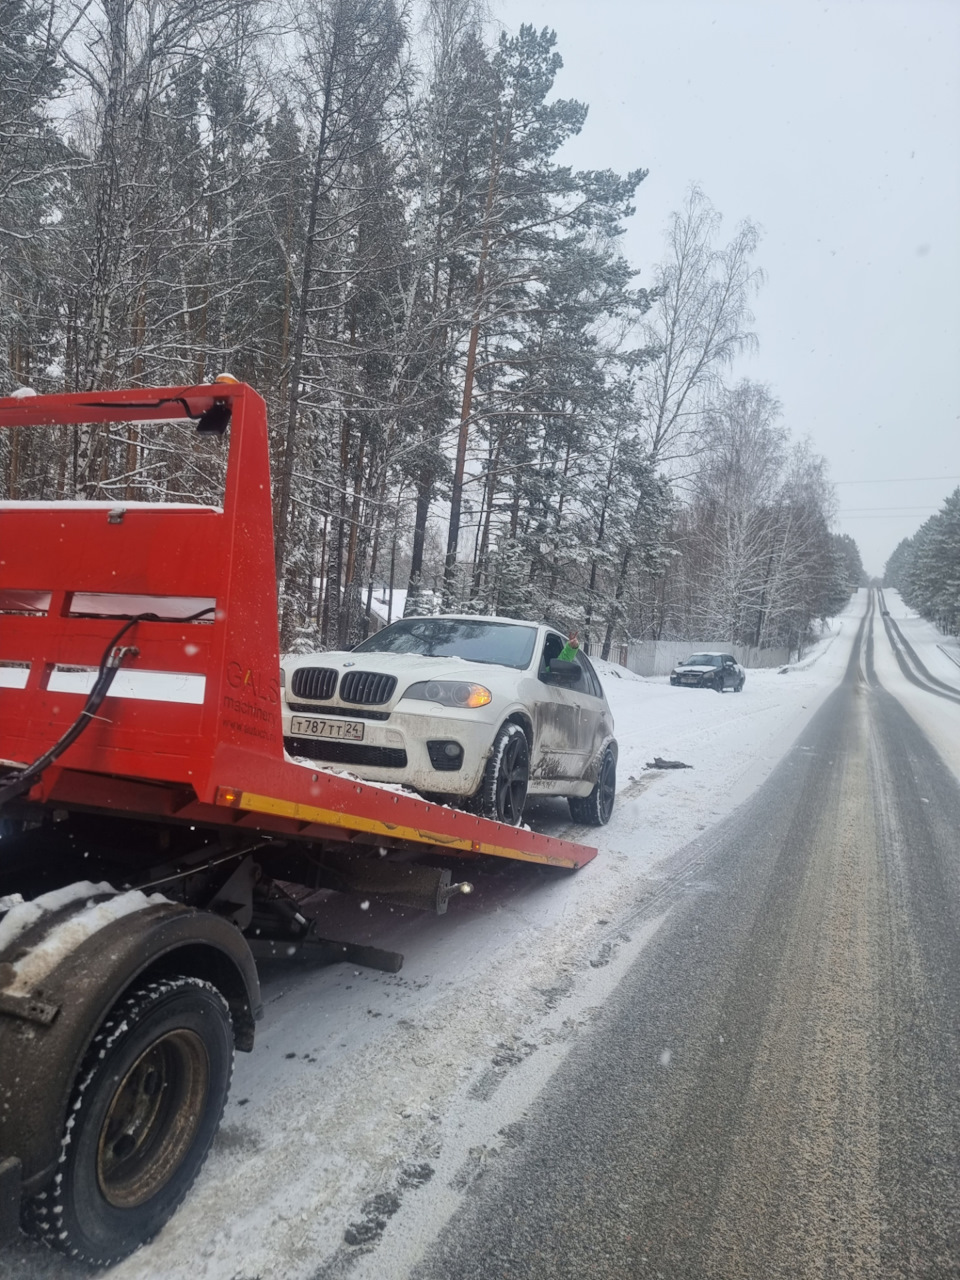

{"left": 23, "top": 977, "right": 233, "bottom": 1267}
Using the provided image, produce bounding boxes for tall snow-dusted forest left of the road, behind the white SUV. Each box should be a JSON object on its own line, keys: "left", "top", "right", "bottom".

{"left": 0, "top": 0, "right": 863, "bottom": 657}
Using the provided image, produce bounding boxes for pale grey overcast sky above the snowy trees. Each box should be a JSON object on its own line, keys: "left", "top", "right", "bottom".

{"left": 492, "top": 0, "right": 960, "bottom": 573}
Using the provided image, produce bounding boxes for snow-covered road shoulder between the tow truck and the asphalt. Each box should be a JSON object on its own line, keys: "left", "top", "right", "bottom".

{"left": 0, "top": 591, "right": 867, "bottom": 1280}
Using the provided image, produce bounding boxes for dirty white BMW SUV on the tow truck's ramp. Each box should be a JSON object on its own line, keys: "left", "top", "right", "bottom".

{"left": 282, "top": 614, "right": 617, "bottom": 826}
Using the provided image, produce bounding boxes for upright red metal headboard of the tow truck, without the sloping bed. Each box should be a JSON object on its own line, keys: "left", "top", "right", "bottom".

{"left": 0, "top": 384, "right": 282, "bottom": 794}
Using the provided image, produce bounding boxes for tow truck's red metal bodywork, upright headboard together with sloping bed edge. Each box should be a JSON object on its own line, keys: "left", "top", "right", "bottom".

{"left": 0, "top": 384, "right": 596, "bottom": 867}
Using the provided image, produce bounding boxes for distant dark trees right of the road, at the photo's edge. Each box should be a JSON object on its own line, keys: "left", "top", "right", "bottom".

{"left": 883, "top": 489, "right": 960, "bottom": 635}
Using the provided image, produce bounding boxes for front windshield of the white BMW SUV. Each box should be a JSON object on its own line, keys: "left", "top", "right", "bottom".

{"left": 353, "top": 618, "right": 536, "bottom": 669}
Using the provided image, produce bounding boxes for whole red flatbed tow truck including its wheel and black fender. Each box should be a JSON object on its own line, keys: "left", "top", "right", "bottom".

{"left": 0, "top": 380, "right": 595, "bottom": 1266}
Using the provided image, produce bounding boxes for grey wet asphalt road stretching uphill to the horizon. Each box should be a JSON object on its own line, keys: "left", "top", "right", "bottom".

{"left": 415, "top": 605, "right": 960, "bottom": 1280}
